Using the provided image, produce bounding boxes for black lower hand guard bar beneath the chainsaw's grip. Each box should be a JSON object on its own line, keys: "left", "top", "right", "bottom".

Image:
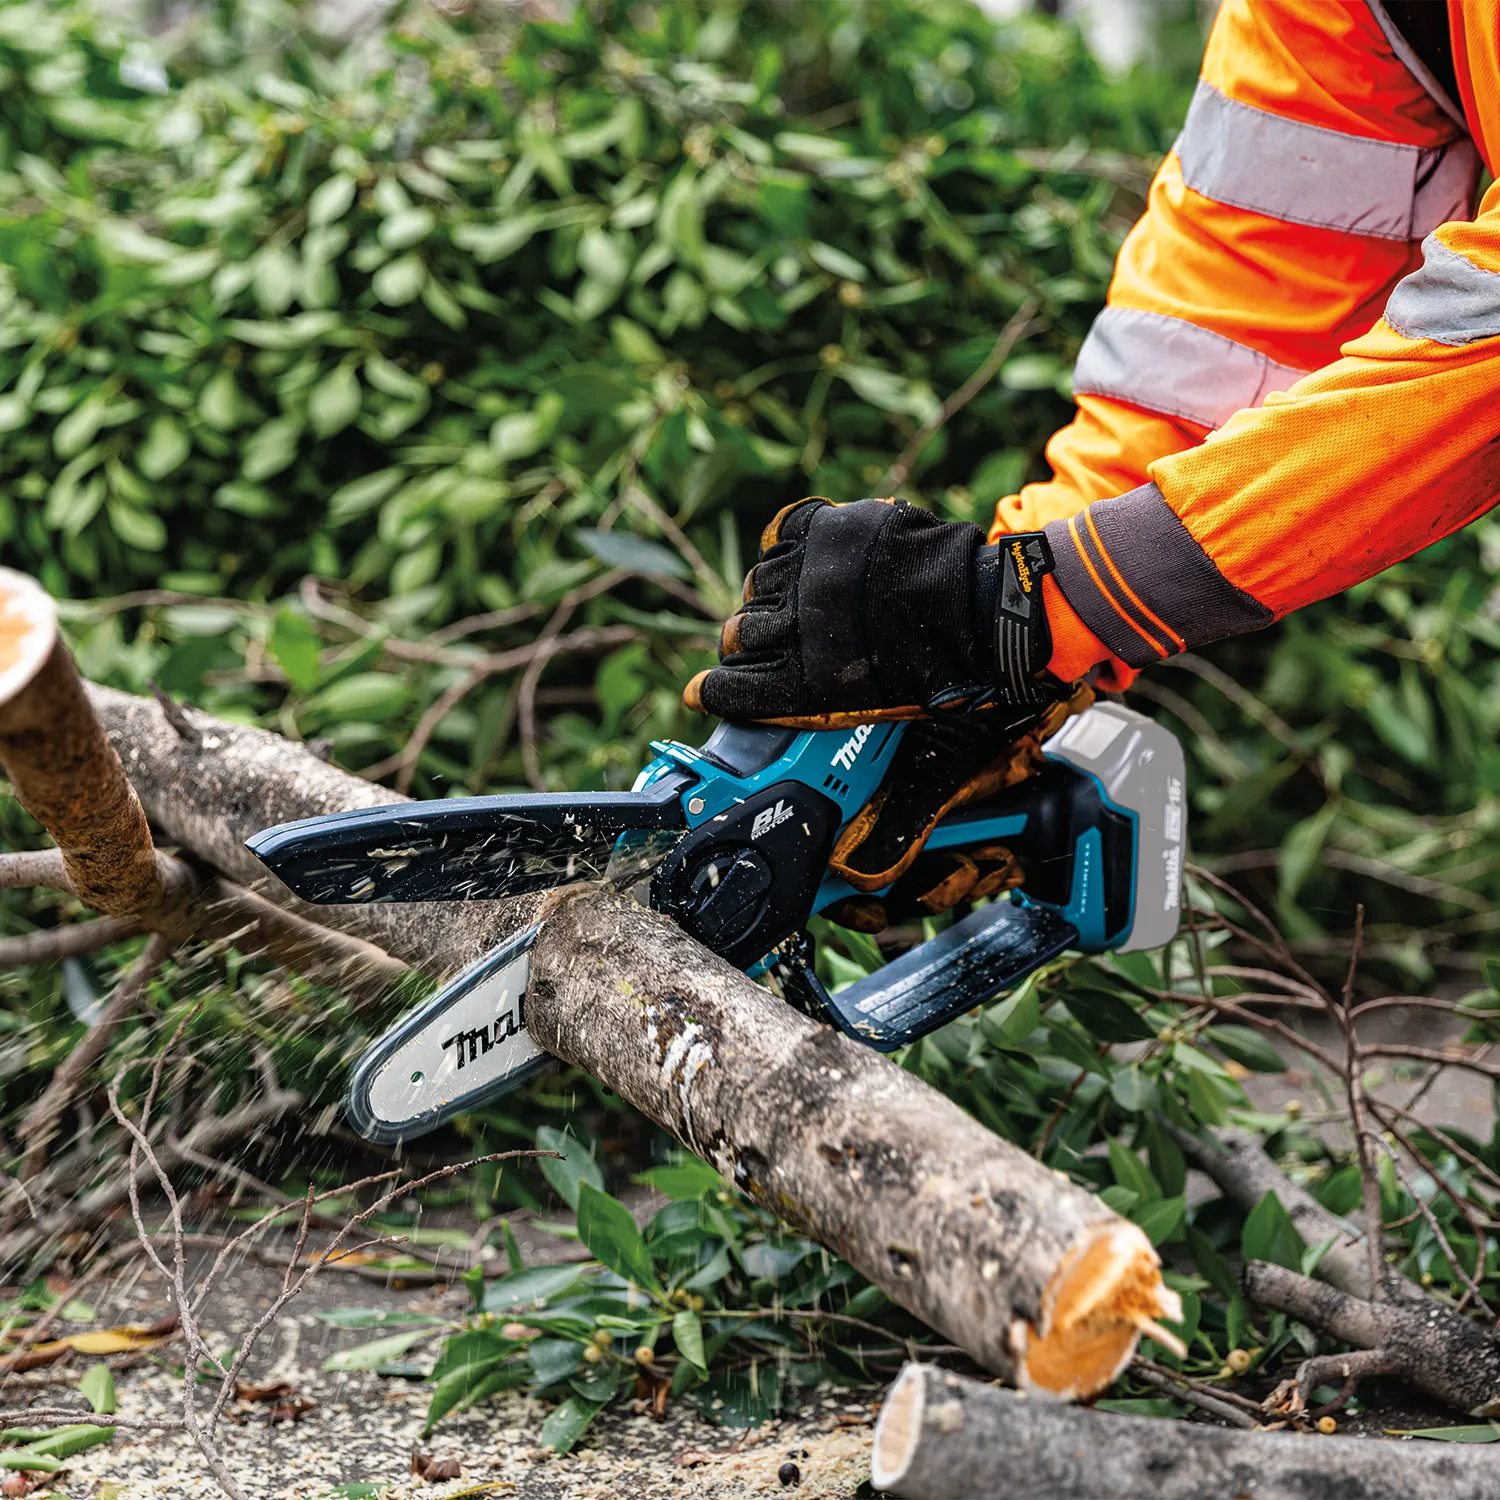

{"left": 770, "top": 900, "right": 1079, "bottom": 1052}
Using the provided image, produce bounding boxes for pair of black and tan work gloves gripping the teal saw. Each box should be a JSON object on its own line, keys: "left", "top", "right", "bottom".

{"left": 683, "top": 498, "right": 1092, "bottom": 920}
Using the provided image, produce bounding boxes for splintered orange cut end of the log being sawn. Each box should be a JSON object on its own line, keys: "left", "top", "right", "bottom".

{"left": 1011, "top": 1220, "right": 1187, "bottom": 1401}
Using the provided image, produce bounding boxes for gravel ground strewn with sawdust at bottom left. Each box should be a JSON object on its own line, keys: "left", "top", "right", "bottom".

{"left": 8, "top": 1197, "right": 878, "bottom": 1500}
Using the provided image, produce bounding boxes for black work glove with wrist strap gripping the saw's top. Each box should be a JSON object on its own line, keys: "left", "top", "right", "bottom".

{"left": 683, "top": 498, "right": 1070, "bottom": 729}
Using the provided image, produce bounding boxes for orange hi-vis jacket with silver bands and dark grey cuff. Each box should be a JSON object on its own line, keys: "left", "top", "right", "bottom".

{"left": 992, "top": 0, "right": 1500, "bottom": 687}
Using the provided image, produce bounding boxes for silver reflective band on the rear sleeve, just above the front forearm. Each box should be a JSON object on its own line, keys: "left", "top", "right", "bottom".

{"left": 1073, "top": 308, "right": 1307, "bottom": 428}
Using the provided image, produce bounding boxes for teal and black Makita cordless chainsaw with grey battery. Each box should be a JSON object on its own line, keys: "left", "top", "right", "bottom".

{"left": 248, "top": 702, "right": 1185, "bottom": 1143}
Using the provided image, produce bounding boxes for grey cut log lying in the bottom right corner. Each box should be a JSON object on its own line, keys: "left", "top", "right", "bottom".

{"left": 870, "top": 1365, "right": 1500, "bottom": 1500}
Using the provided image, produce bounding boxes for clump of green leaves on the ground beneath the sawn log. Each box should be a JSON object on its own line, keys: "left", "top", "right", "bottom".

{"left": 405, "top": 1130, "right": 948, "bottom": 1452}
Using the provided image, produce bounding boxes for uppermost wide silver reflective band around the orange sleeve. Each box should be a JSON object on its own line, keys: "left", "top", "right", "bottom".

{"left": 1176, "top": 81, "right": 1479, "bottom": 240}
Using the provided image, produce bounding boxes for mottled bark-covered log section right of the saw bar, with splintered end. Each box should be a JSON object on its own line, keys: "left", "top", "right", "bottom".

{"left": 527, "top": 893, "right": 1176, "bottom": 1395}
